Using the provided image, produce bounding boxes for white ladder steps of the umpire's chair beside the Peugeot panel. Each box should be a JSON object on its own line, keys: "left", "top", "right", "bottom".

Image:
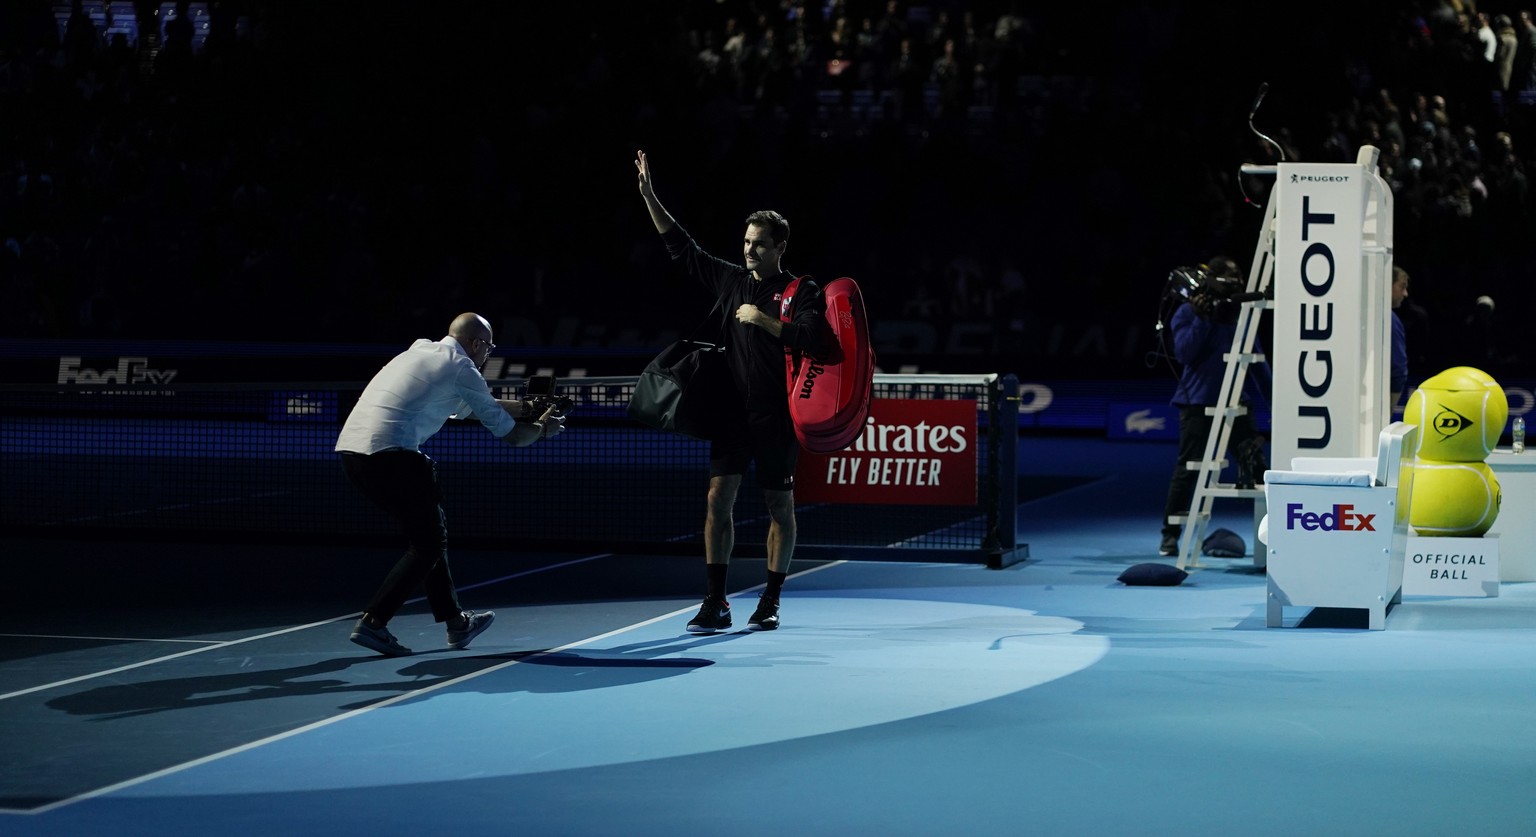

{"left": 1167, "top": 201, "right": 1275, "bottom": 570}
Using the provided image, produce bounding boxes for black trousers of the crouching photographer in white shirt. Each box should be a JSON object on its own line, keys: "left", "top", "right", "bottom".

{"left": 341, "top": 450, "right": 461, "bottom": 622}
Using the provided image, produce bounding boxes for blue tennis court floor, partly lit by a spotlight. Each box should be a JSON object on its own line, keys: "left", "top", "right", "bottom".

{"left": 0, "top": 438, "right": 1536, "bottom": 835}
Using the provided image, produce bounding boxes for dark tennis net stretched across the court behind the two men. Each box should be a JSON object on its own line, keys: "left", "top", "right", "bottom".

{"left": 0, "top": 375, "right": 1028, "bottom": 567}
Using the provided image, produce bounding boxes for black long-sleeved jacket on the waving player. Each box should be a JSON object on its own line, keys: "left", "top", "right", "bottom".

{"left": 662, "top": 226, "right": 828, "bottom": 418}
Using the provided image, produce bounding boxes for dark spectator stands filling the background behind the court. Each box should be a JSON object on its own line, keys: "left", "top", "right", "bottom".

{"left": 0, "top": 0, "right": 1536, "bottom": 376}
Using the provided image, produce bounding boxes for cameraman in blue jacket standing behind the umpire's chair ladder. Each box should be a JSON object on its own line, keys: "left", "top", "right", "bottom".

{"left": 1158, "top": 256, "right": 1269, "bottom": 556}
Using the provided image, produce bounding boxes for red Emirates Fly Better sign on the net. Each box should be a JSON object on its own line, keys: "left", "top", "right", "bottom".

{"left": 794, "top": 399, "right": 977, "bottom": 505}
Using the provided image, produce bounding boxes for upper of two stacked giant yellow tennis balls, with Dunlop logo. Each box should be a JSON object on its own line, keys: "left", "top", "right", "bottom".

{"left": 1402, "top": 366, "right": 1510, "bottom": 462}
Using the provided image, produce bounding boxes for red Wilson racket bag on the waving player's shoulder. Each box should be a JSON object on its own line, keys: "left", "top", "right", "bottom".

{"left": 779, "top": 276, "right": 874, "bottom": 453}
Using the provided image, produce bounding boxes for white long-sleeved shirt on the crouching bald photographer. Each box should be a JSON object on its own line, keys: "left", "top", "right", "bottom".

{"left": 336, "top": 338, "right": 516, "bottom": 453}
